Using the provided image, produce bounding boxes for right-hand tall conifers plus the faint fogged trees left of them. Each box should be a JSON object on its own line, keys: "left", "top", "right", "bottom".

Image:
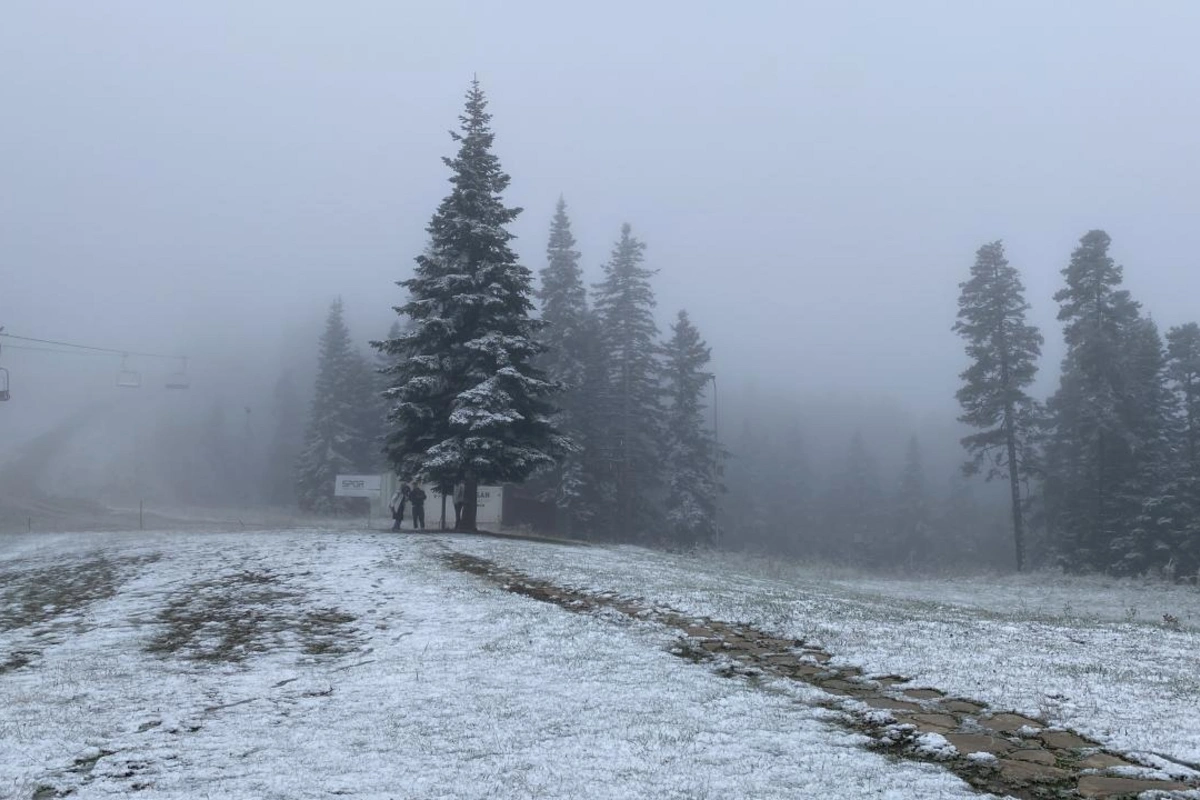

{"left": 726, "top": 230, "right": 1200, "bottom": 577}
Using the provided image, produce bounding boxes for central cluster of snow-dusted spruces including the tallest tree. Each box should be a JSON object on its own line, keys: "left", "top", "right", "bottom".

{"left": 276, "top": 85, "right": 720, "bottom": 546}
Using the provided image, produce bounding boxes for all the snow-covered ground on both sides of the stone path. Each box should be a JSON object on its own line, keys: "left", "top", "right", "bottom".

{"left": 0, "top": 530, "right": 1200, "bottom": 798}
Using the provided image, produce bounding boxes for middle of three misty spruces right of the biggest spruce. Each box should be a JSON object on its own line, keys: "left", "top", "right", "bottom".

{"left": 595, "top": 223, "right": 662, "bottom": 540}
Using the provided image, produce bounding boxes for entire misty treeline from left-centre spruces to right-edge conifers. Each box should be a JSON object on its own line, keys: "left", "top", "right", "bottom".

{"left": 255, "top": 85, "right": 1200, "bottom": 576}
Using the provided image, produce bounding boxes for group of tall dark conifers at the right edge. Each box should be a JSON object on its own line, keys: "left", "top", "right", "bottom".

{"left": 955, "top": 230, "right": 1200, "bottom": 576}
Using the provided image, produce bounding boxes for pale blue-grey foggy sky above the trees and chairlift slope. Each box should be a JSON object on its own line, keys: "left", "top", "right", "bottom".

{"left": 0, "top": 0, "right": 1200, "bottom": 520}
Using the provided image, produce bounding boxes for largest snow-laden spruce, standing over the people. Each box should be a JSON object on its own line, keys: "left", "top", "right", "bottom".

{"left": 373, "top": 82, "right": 571, "bottom": 530}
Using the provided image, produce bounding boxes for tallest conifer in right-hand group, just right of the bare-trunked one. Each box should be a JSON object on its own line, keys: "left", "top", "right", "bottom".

{"left": 1045, "top": 230, "right": 1139, "bottom": 570}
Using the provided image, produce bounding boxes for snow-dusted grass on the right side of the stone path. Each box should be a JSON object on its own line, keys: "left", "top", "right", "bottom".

{"left": 451, "top": 540, "right": 1200, "bottom": 764}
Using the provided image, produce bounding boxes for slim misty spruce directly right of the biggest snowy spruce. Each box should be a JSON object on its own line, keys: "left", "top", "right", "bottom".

{"left": 538, "top": 198, "right": 604, "bottom": 535}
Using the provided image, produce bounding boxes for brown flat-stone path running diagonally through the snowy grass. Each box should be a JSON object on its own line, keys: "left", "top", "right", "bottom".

{"left": 445, "top": 553, "right": 1200, "bottom": 800}
